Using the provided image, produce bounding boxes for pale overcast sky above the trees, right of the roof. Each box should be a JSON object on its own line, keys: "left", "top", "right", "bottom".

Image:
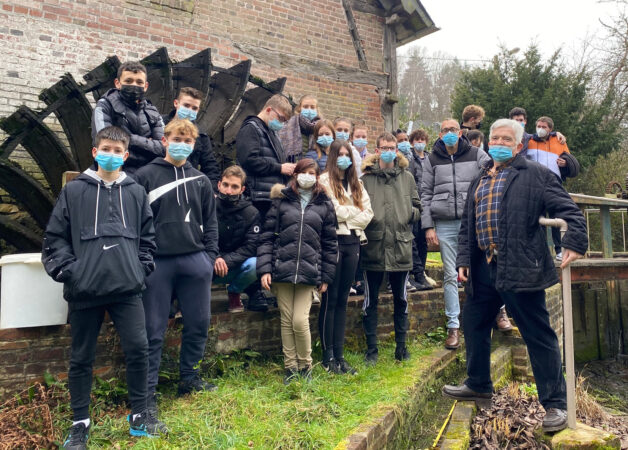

{"left": 398, "top": 0, "right": 617, "bottom": 63}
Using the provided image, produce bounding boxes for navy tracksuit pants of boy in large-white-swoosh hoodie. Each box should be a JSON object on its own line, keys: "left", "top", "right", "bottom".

{"left": 143, "top": 251, "right": 214, "bottom": 395}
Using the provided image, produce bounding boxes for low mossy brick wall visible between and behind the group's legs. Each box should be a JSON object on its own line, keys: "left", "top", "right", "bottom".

{"left": 0, "top": 289, "right": 456, "bottom": 399}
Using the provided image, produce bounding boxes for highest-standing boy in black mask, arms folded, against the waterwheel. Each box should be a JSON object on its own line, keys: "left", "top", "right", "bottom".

{"left": 92, "top": 61, "right": 164, "bottom": 174}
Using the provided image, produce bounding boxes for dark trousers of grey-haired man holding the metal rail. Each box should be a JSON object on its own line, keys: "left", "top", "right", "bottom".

{"left": 462, "top": 250, "right": 567, "bottom": 410}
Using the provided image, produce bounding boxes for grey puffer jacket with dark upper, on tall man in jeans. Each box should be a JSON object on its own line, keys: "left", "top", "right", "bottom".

{"left": 421, "top": 136, "right": 491, "bottom": 229}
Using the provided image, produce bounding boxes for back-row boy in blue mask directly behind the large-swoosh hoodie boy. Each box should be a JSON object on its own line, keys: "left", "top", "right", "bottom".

{"left": 163, "top": 87, "right": 220, "bottom": 191}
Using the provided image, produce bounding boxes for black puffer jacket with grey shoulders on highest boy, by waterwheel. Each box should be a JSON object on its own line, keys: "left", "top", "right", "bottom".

{"left": 92, "top": 89, "right": 166, "bottom": 173}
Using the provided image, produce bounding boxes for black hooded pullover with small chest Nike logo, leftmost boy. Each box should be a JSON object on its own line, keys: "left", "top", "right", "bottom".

{"left": 41, "top": 169, "right": 155, "bottom": 309}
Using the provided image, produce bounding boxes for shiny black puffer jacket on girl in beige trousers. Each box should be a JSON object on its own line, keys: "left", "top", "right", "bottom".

{"left": 257, "top": 185, "right": 338, "bottom": 286}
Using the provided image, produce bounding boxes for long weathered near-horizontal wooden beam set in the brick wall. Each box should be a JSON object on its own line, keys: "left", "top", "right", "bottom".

{"left": 233, "top": 42, "right": 388, "bottom": 91}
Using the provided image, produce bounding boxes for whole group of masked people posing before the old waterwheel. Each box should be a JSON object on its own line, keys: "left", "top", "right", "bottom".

{"left": 42, "top": 62, "right": 586, "bottom": 449}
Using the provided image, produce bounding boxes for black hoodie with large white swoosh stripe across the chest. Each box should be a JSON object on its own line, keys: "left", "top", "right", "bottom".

{"left": 135, "top": 158, "right": 218, "bottom": 264}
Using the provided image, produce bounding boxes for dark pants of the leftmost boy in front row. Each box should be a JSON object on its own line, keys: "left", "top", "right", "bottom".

{"left": 68, "top": 295, "right": 148, "bottom": 421}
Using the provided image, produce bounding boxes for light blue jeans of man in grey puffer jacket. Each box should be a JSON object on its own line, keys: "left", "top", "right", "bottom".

{"left": 435, "top": 220, "right": 460, "bottom": 328}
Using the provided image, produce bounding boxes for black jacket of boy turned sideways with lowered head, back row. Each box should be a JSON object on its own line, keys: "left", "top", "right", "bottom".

{"left": 236, "top": 116, "right": 286, "bottom": 202}
